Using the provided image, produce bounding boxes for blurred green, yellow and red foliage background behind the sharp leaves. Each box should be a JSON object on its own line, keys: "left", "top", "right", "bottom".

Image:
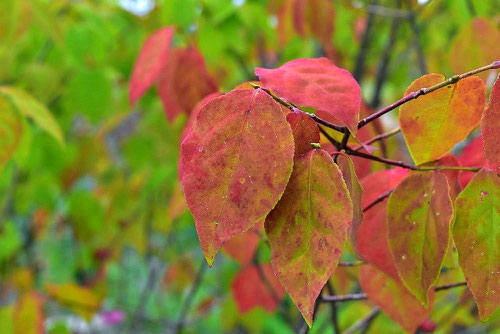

{"left": 0, "top": 0, "right": 500, "bottom": 333}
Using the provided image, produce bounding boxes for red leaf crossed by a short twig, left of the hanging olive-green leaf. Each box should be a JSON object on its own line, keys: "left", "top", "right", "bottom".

{"left": 357, "top": 168, "right": 408, "bottom": 278}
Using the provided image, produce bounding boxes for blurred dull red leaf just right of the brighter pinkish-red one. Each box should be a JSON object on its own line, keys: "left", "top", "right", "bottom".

{"left": 158, "top": 47, "right": 217, "bottom": 121}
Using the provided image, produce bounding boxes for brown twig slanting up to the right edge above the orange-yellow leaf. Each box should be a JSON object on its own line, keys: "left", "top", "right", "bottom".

{"left": 358, "top": 60, "right": 500, "bottom": 129}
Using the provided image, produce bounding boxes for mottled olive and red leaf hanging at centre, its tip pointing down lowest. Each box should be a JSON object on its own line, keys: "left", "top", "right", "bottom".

{"left": 265, "top": 149, "right": 352, "bottom": 326}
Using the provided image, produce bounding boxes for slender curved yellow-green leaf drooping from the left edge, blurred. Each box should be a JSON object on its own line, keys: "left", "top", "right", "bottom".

{"left": 0, "top": 86, "right": 64, "bottom": 144}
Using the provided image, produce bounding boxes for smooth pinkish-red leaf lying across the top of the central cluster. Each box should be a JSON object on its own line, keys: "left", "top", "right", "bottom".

{"left": 255, "top": 58, "right": 361, "bottom": 134}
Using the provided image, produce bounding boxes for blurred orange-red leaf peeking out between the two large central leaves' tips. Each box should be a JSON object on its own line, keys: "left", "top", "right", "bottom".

{"left": 222, "top": 222, "right": 264, "bottom": 267}
